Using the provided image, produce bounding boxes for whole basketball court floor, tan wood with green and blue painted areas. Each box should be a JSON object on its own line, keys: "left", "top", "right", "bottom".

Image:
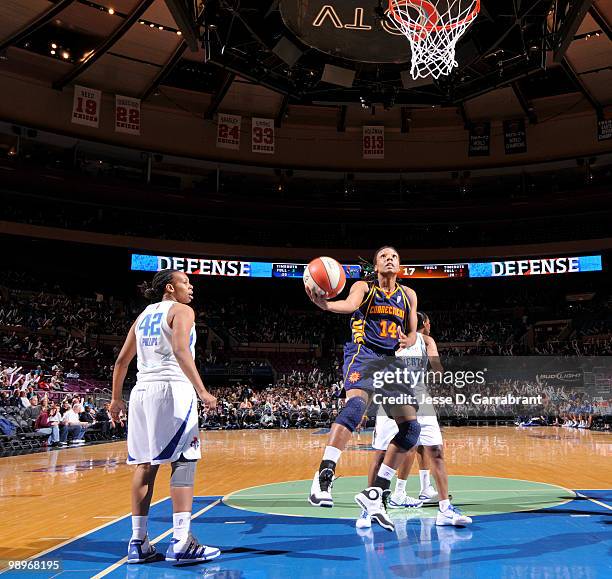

{"left": 0, "top": 427, "right": 612, "bottom": 577}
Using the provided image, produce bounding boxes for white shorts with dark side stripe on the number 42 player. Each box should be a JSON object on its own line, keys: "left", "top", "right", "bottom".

{"left": 127, "top": 382, "right": 202, "bottom": 464}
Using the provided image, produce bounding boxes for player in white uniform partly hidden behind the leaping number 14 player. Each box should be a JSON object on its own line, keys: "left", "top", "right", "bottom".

{"left": 357, "top": 312, "right": 472, "bottom": 528}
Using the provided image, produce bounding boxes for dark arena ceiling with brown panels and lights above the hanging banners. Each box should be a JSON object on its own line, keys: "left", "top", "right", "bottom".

{"left": 0, "top": 0, "right": 612, "bottom": 130}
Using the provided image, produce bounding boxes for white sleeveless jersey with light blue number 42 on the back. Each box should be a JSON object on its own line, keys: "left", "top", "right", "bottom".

{"left": 134, "top": 300, "right": 196, "bottom": 382}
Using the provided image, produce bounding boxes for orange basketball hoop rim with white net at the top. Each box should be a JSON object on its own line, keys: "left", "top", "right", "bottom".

{"left": 388, "top": 0, "right": 480, "bottom": 80}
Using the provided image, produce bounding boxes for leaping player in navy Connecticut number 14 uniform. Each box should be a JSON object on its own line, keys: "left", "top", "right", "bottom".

{"left": 306, "top": 246, "right": 420, "bottom": 531}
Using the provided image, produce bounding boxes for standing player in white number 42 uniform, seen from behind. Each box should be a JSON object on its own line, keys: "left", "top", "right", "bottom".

{"left": 110, "top": 270, "right": 220, "bottom": 564}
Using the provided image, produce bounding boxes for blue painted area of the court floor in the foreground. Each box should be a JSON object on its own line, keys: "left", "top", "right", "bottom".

{"left": 7, "top": 489, "right": 612, "bottom": 579}
